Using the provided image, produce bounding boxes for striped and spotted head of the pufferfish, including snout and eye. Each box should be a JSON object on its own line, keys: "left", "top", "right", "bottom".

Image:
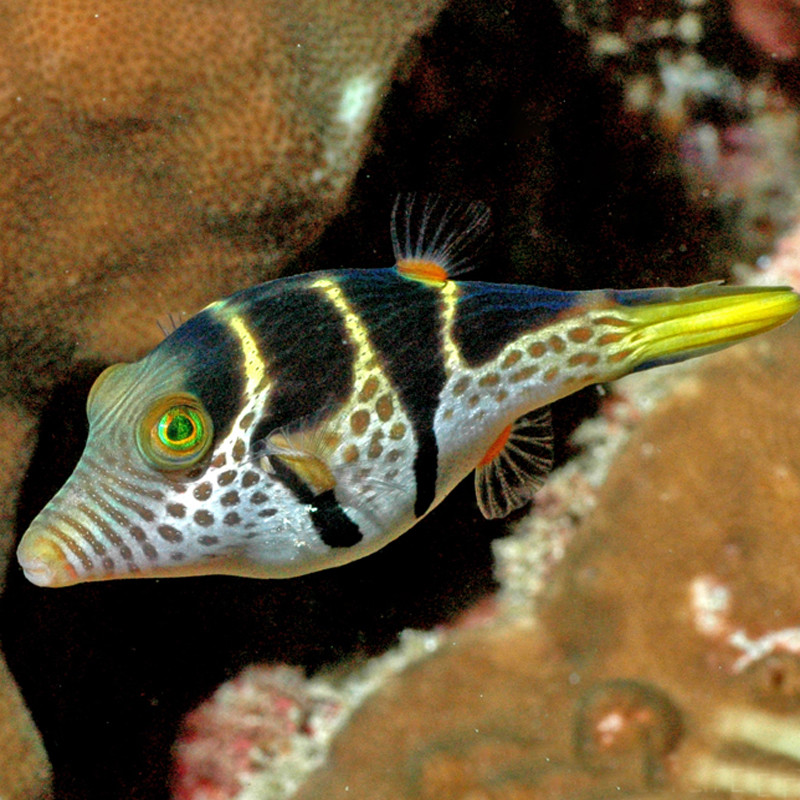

{"left": 17, "top": 353, "right": 276, "bottom": 586}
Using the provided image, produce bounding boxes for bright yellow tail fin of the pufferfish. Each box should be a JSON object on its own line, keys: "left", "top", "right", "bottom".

{"left": 592, "top": 283, "right": 800, "bottom": 373}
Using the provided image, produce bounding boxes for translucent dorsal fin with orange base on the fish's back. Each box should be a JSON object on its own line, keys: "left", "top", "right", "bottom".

{"left": 392, "top": 194, "right": 490, "bottom": 283}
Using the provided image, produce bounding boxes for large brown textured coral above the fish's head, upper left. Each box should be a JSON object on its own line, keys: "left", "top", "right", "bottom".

{"left": 0, "top": 0, "right": 438, "bottom": 378}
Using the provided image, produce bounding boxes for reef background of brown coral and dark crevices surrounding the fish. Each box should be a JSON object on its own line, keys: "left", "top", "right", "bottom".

{"left": 0, "top": 0, "right": 800, "bottom": 800}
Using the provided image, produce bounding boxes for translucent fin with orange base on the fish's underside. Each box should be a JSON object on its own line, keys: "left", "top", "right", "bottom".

{"left": 475, "top": 408, "right": 553, "bottom": 519}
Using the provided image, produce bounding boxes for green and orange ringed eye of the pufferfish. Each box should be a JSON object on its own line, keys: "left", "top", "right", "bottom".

{"left": 136, "top": 394, "right": 214, "bottom": 470}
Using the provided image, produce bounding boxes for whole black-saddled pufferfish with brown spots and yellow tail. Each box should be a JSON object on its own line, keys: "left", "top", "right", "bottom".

{"left": 17, "top": 202, "right": 800, "bottom": 586}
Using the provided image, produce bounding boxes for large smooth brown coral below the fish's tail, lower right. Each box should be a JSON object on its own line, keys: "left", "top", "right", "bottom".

{"left": 290, "top": 322, "right": 800, "bottom": 800}
